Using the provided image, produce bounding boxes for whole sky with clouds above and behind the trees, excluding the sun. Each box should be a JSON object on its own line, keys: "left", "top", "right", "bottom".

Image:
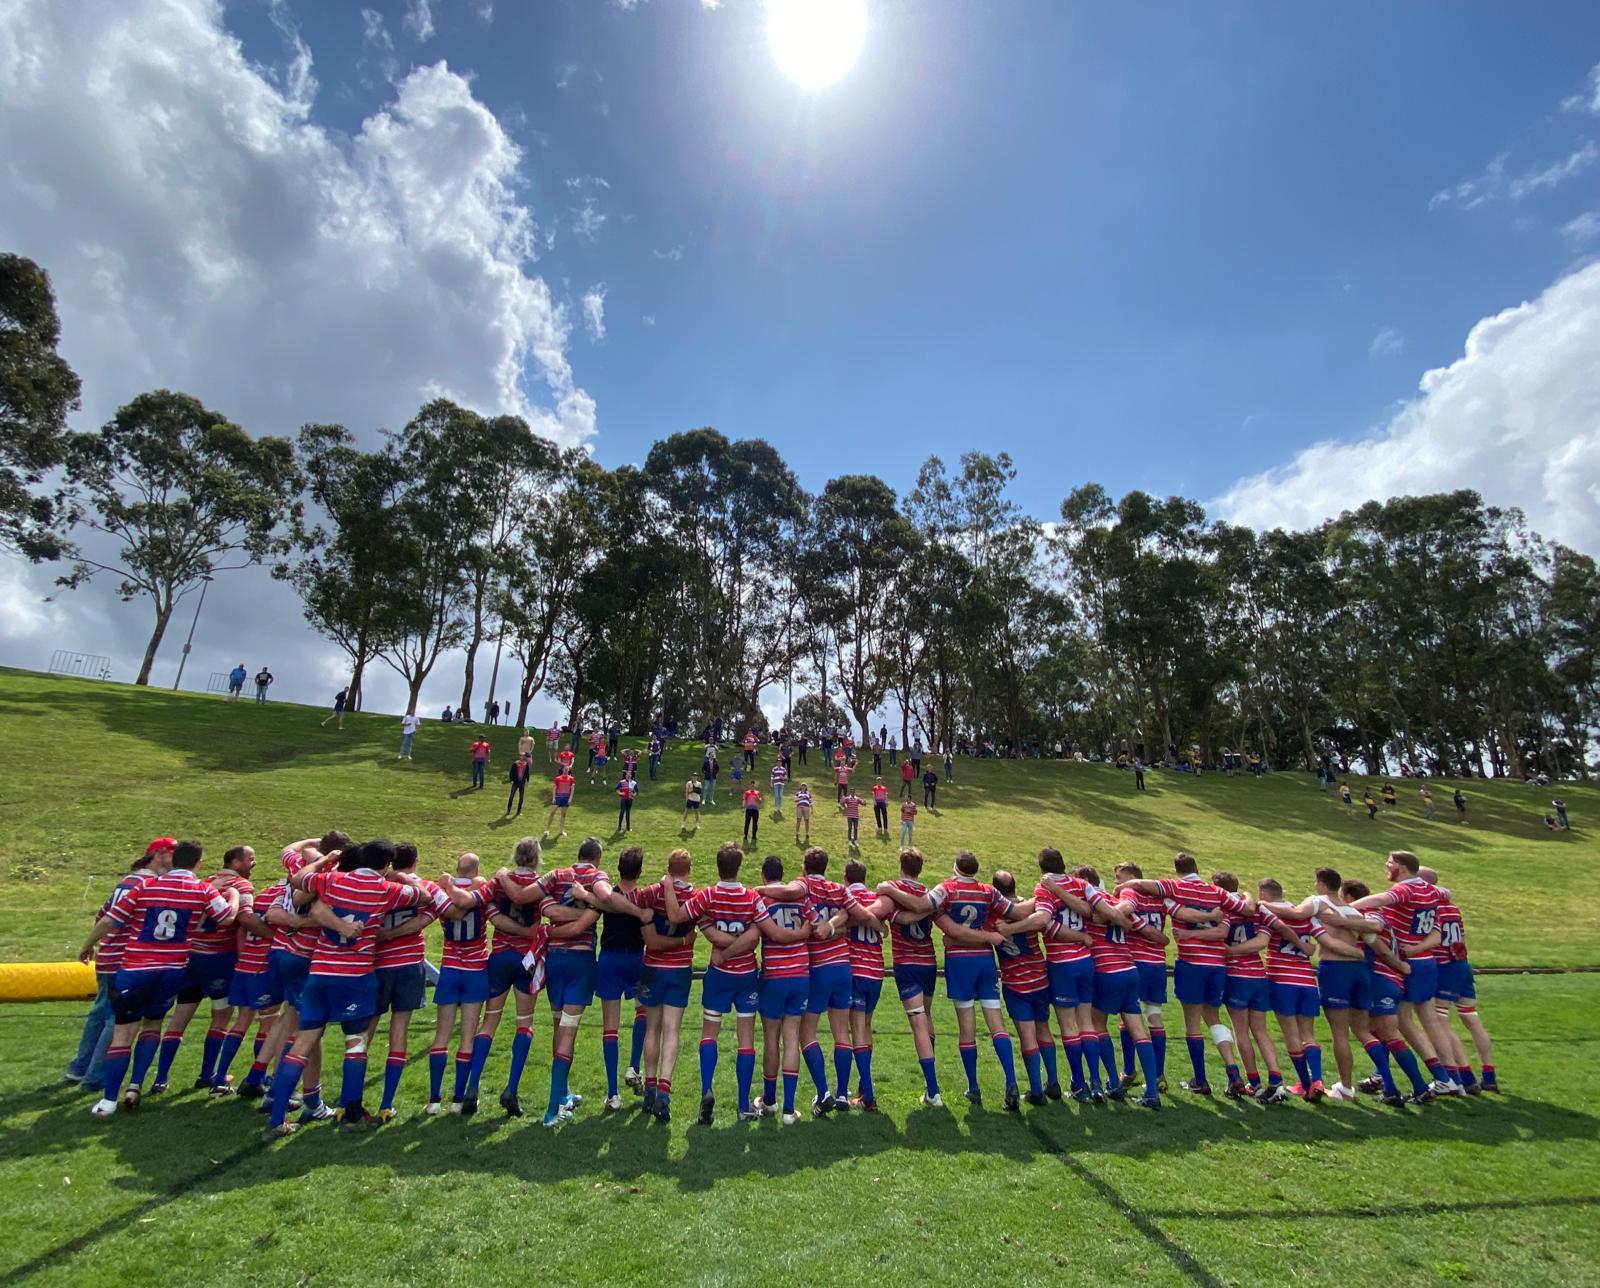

{"left": 0, "top": 0, "right": 1600, "bottom": 709}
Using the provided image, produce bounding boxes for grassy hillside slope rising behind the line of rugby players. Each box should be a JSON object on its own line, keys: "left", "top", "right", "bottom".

{"left": 0, "top": 672, "right": 1600, "bottom": 966}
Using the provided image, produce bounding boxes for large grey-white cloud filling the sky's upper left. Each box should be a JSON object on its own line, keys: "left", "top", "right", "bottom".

{"left": 0, "top": 0, "right": 595, "bottom": 706}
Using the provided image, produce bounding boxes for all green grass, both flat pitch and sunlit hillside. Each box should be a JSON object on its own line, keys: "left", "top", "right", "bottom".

{"left": 0, "top": 672, "right": 1600, "bottom": 1285}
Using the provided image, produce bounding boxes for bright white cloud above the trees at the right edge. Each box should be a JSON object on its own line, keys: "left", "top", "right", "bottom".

{"left": 1214, "top": 264, "right": 1600, "bottom": 552}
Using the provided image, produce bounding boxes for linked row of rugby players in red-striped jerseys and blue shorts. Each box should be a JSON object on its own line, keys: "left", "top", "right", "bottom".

{"left": 69, "top": 832, "right": 1498, "bottom": 1139}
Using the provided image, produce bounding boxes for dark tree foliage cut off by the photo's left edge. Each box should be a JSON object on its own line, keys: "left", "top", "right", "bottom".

{"left": 0, "top": 254, "right": 78, "bottom": 560}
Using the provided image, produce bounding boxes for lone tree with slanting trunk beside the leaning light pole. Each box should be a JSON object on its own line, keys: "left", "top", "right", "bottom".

{"left": 61, "top": 389, "right": 301, "bottom": 685}
